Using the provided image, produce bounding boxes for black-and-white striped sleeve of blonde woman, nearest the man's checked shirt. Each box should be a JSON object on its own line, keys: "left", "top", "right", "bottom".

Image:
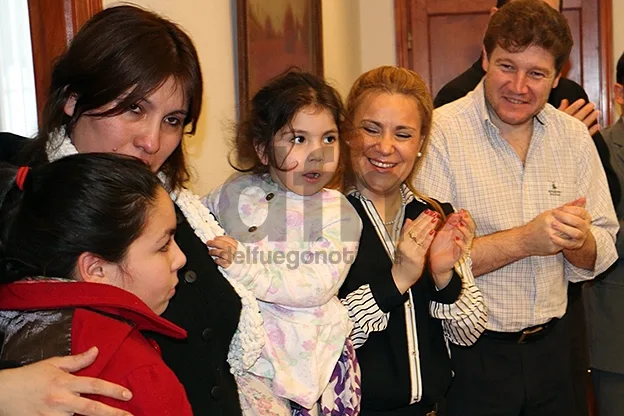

{"left": 429, "top": 257, "right": 487, "bottom": 346}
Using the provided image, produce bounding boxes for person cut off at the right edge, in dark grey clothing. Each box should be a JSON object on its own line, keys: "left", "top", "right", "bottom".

{"left": 583, "top": 50, "right": 624, "bottom": 416}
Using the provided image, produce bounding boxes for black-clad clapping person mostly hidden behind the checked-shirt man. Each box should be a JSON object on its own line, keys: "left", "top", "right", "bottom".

{"left": 433, "top": 0, "right": 622, "bottom": 416}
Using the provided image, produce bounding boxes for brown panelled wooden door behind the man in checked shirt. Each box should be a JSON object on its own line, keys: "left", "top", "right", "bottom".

{"left": 395, "top": 0, "right": 614, "bottom": 125}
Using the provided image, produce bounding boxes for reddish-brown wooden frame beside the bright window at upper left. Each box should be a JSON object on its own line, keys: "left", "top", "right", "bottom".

{"left": 28, "top": 0, "right": 102, "bottom": 118}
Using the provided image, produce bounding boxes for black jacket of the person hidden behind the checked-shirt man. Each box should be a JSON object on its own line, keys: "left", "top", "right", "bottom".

{"left": 433, "top": 59, "right": 622, "bottom": 206}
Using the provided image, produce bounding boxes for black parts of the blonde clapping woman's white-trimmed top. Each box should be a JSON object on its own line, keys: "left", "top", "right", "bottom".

{"left": 339, "top": 196, "right": 461, "bottom": 416}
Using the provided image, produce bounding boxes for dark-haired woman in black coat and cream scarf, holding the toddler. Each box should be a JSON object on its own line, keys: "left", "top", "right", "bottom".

{"left": 0, "top": 6, "right": 249, "bottom": 416}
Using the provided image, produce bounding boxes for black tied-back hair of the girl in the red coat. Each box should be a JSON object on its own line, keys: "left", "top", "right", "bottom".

{"left": 0, "top": 153, "right": 162, "bottom": 283}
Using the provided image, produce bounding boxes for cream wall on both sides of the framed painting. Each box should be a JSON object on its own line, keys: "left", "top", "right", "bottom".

{"left": 103, "top": 0, "right": 394, "bottom": 195}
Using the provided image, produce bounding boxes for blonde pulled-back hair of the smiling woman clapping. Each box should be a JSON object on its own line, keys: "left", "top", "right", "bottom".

{"left": 342, "top": 66, "right": 444, "bottom": 217}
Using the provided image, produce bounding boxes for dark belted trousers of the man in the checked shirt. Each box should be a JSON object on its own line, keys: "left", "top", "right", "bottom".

{"left": 447, "top": 317, "right": 575, "bottom": 416}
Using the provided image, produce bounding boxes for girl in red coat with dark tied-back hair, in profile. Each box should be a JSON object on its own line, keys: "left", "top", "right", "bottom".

{"left": 0, "top": 154, "right": 192, "bottom": 416}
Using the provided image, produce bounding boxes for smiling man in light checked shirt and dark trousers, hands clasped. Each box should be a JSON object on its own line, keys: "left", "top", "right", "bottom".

{"left": 415, "top": 0, "right": 618, "bottom": 416}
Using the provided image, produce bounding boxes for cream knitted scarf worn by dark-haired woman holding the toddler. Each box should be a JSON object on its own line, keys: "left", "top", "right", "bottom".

{"left": 46, "top": 128, "right": 265, "bottom": 375}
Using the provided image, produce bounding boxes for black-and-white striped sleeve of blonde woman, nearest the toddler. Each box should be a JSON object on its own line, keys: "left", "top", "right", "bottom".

{"left": 341, "top": 285, "right": 390, "bottom": 348}
